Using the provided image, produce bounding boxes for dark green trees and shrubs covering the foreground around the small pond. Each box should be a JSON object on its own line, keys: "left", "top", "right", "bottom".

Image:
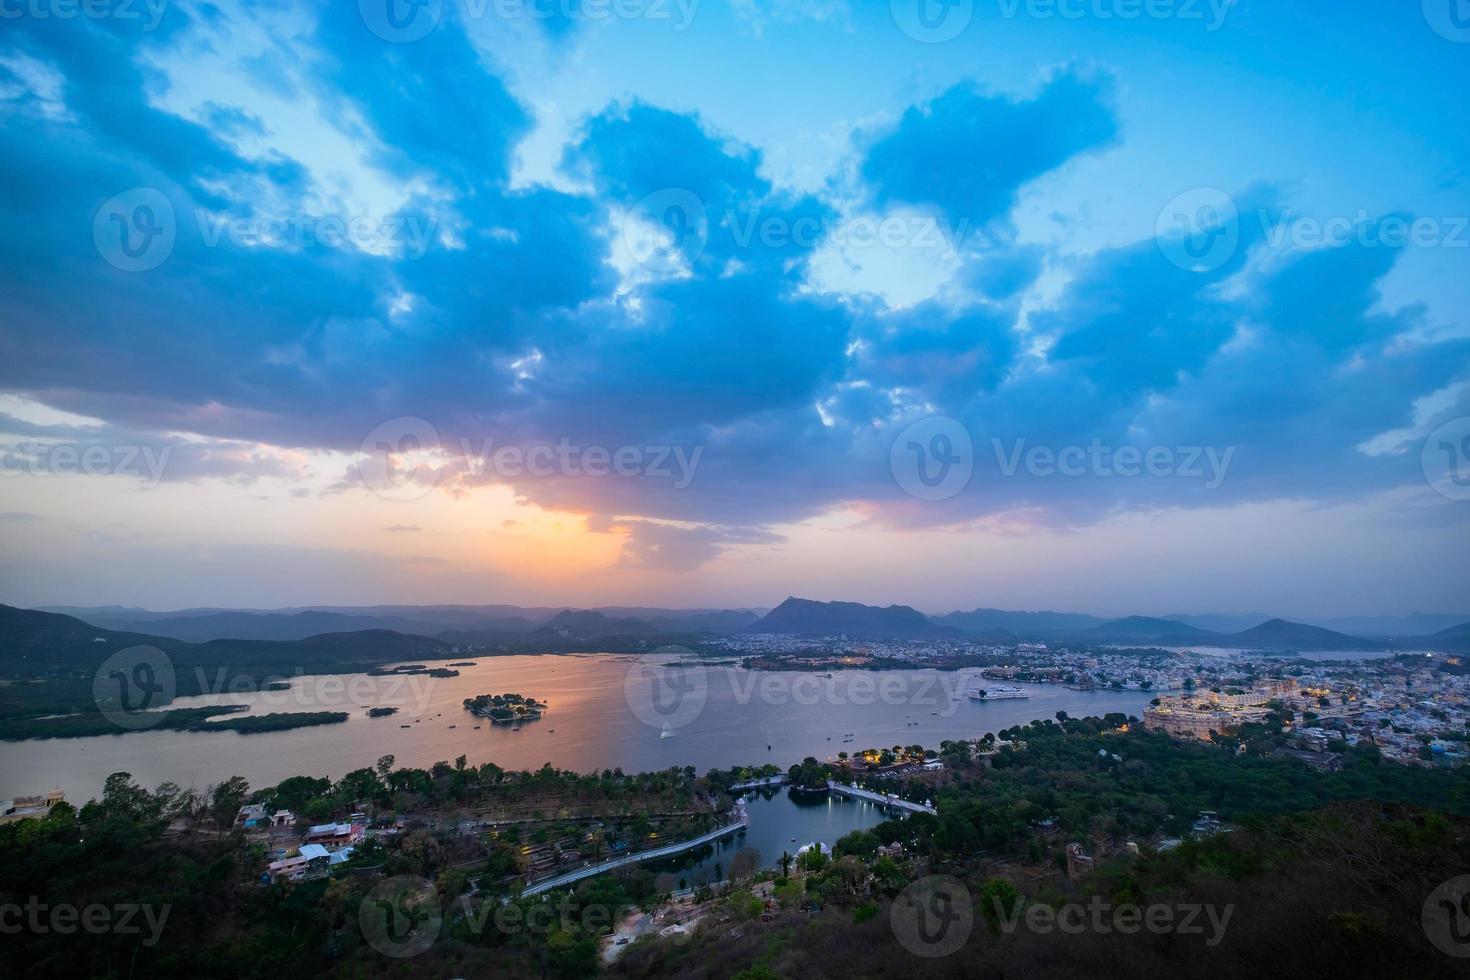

{"left": 0, "top": 716, "right": 1470, "bottom": 980}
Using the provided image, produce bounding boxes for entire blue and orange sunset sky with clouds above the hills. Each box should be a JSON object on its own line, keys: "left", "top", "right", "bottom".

{"left": 0, "top": 0, "right": 1470, "bottom": 617}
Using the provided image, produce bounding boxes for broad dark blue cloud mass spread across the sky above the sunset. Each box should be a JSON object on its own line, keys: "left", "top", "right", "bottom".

{"left": 0, "top": 4, "right": 1470, "bottom": 569}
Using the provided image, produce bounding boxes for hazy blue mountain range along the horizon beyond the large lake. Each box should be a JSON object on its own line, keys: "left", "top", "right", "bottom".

{"left": 17, "top": 597, "right": 1470, "bottom": 663}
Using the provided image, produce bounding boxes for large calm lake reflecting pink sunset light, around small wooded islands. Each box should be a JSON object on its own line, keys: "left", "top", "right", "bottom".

{"left": 0, "top": 654, "right": 1152, "bottom": 805}
